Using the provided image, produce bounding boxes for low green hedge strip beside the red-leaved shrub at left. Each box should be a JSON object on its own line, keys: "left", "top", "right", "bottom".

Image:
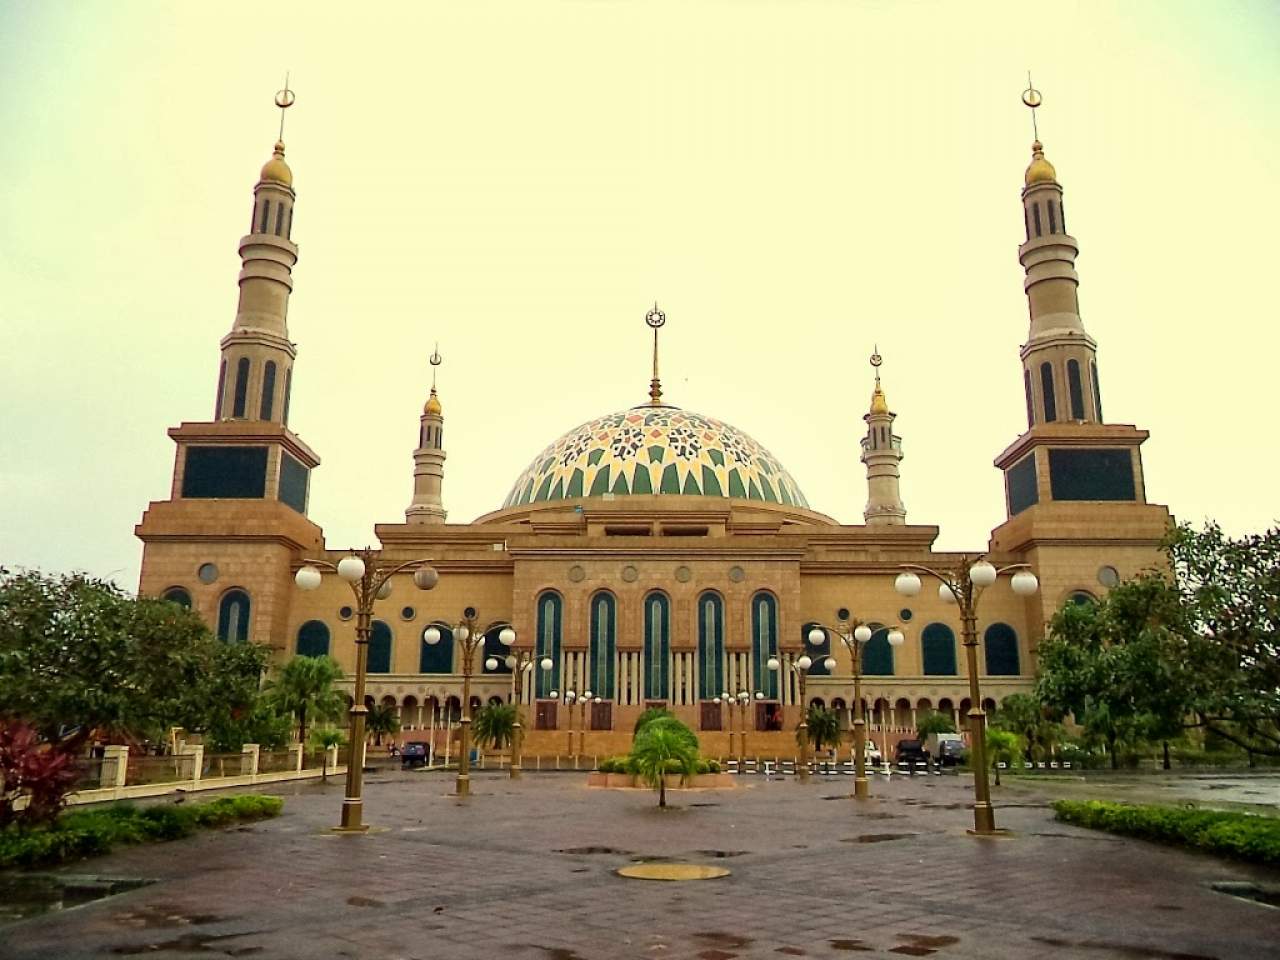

{"left": 0, "top": 794, "right": 284, "bottom": 868}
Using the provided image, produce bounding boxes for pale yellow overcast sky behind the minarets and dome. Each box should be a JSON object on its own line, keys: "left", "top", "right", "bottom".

{"left": 0, "top": 0, "right": 1280, "bottom": 588}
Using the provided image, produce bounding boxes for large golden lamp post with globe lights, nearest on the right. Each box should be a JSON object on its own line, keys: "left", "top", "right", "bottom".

{"left": 893, "top": 557, "right": 1039, "bottom": 836}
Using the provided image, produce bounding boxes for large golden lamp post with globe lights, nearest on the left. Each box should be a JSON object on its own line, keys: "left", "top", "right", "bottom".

{"left": 293, "top": 547, "right": 440, "bottom": 833}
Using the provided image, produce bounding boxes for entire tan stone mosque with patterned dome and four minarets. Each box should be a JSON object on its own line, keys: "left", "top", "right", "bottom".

{"left": 136, "top": 95, "right": 1170, "bottom": 756}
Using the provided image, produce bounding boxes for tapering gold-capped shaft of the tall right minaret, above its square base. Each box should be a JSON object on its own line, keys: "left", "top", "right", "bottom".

{"left": 1018, "top": 80, "right": 1102, "bottom": 429}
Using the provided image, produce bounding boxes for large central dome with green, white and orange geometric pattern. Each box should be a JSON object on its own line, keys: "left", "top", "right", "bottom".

{"left": 503, "top": 403, "right": 809, "bottom": 509}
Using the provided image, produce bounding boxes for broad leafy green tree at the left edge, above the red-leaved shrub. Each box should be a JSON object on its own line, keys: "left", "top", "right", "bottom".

{"left": 0, "top": 568, "right": 269, "bottom": 750}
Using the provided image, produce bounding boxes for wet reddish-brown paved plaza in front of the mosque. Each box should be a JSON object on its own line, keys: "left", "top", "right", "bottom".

{"left": 0, "top": 771, "right": 1280, "bottom": 960}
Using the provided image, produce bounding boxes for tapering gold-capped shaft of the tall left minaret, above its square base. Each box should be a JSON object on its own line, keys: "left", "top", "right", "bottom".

{"left": 214, "top": 83, "right": 298, "bottom": 425}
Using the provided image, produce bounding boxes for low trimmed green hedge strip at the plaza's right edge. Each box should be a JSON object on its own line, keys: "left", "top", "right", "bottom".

{"left": 1053, "top": 800, "right": 1280, "bottom": 864}
